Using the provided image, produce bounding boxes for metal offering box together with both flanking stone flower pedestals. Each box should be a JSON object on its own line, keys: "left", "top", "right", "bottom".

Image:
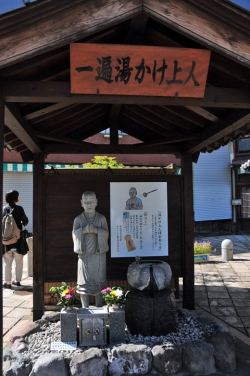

{"left": 61, "top": 307, "right": 125, "bottom": 347}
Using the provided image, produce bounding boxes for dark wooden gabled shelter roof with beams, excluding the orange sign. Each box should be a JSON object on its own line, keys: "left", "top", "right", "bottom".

{"left": 0, "top": 0, "right": 250, "bottom": 162}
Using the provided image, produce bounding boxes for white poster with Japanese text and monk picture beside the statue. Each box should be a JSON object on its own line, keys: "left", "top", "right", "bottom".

{"left": 110, "top": 182, "right": 168, "bottom": 257}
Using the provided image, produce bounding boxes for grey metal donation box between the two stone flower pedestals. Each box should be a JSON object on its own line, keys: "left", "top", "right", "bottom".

{"left": 78, "top": 307, "right": 108, "bottom": 346}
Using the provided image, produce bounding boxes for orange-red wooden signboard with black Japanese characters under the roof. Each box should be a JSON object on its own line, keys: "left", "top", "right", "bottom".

{"left": 70, "top": 43, "right": 210, "bottom": 98}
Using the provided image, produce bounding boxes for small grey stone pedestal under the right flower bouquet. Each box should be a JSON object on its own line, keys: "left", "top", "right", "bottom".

{"left": 109, "top": 308, "right": 125, "bottom": 345}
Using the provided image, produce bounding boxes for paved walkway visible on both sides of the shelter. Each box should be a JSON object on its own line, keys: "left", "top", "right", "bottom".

{"left": 3, "top": 235, "right": 250, "bottom": 376}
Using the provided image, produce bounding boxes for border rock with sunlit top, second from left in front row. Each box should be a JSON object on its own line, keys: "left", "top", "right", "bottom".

{"left": 29, "top": 353, "right": 69, "bottom": 376}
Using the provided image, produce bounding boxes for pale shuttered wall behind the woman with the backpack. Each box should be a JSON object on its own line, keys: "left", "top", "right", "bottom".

{"left": 3, "top": 171, "right": 33, "bottom": 232}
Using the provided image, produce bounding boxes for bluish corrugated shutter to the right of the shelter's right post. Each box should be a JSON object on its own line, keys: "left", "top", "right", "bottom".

{"left": 193, "top": 146, "right": 232, "bottom": 221}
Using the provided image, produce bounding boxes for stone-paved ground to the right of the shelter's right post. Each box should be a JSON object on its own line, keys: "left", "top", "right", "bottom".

{"left": 191, "top": 235, "right": 250, "bottom": 338}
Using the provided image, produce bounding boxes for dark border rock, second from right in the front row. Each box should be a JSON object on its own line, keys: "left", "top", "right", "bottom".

{"left": 182, "top": 341, "right": 216, "bottom": 375}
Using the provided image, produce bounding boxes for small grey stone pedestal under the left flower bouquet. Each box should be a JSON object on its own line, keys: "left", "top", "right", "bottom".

{"left": 60, "top": 308, "right": 77, "bottom": 342}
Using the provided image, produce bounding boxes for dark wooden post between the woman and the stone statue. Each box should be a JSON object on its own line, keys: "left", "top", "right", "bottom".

{"left": 33, "top": 154, "right": 45, "bottom": 321}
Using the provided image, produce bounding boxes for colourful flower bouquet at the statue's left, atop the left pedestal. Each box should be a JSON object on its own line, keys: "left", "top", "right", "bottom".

{"left": 49, "top": 282, "right": 80, "bottom": 308}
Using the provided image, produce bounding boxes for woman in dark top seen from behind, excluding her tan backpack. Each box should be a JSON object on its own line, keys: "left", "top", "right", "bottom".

{"left": 2, "top": 190, "right": 29, "bottom": 289}
